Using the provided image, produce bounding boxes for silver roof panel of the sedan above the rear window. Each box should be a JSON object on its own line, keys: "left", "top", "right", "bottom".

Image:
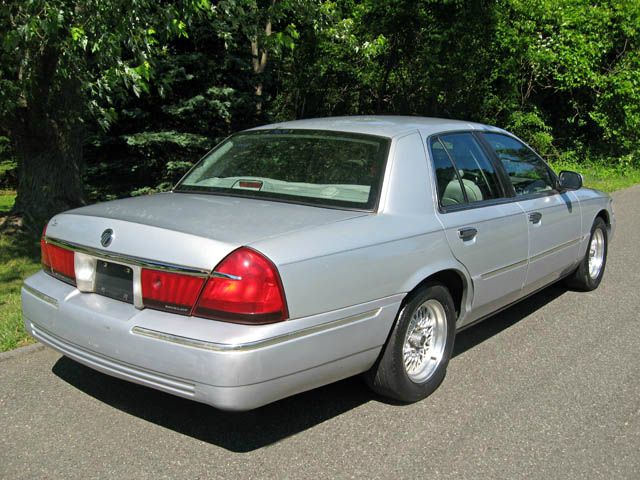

{"left": 251, "top": 115, "right": 504, "bottom": 138}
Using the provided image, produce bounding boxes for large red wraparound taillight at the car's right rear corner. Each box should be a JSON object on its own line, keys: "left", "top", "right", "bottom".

{"left": 193, "top": 247, "right": 288, "bottom": 324}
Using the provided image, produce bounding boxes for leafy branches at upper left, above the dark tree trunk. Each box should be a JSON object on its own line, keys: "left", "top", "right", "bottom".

{"left": 0, "top": 0, "right": 191, "bottom": 127}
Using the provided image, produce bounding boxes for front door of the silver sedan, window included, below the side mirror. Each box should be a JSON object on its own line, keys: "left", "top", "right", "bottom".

{"left": 481, "top": 133, "right": 581, "bottom": 294}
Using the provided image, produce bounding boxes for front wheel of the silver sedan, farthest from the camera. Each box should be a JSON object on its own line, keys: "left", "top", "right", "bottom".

{"left": 566, "top": 217, "right": 608, "bottom": 292}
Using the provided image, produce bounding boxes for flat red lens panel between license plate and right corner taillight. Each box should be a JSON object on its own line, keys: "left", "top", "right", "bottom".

{"left": 141, "top": 268, "right": 205, "bottom": 314}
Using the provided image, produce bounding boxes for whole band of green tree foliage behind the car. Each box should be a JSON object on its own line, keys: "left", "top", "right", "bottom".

{"left": 0, "top": 0, "right": 640, "bottom": 208}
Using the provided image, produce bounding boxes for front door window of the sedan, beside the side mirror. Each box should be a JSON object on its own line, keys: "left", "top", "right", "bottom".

{"left": 482, "top": 133, "right": 555, "bottom": 195}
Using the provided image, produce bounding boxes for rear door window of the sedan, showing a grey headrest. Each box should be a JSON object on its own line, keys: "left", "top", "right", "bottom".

{"left": 438, "top": 133, "right": 502, "bottom": 203}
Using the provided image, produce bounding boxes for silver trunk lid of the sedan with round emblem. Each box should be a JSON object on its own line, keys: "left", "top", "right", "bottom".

{"left": 47, "top": 193, "right": 367, "bottom": 271}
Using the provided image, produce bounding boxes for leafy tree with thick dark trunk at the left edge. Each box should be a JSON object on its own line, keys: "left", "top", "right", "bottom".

{"left": 0, "top": 0, "right": 198, "bottom": 229}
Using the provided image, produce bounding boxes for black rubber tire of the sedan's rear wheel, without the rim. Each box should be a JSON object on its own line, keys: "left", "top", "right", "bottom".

{"left": 365, "top": 283, "right": 456, "bottom": 403}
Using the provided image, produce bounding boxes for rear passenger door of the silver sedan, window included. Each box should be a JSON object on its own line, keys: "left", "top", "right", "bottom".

{"left": 429, "top": 132, "right": 528, "bottom": 324}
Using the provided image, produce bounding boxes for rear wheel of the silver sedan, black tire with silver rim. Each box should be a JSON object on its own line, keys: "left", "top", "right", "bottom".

{"left": 365, "top": 283, "right": 456, "bottom": 402}
